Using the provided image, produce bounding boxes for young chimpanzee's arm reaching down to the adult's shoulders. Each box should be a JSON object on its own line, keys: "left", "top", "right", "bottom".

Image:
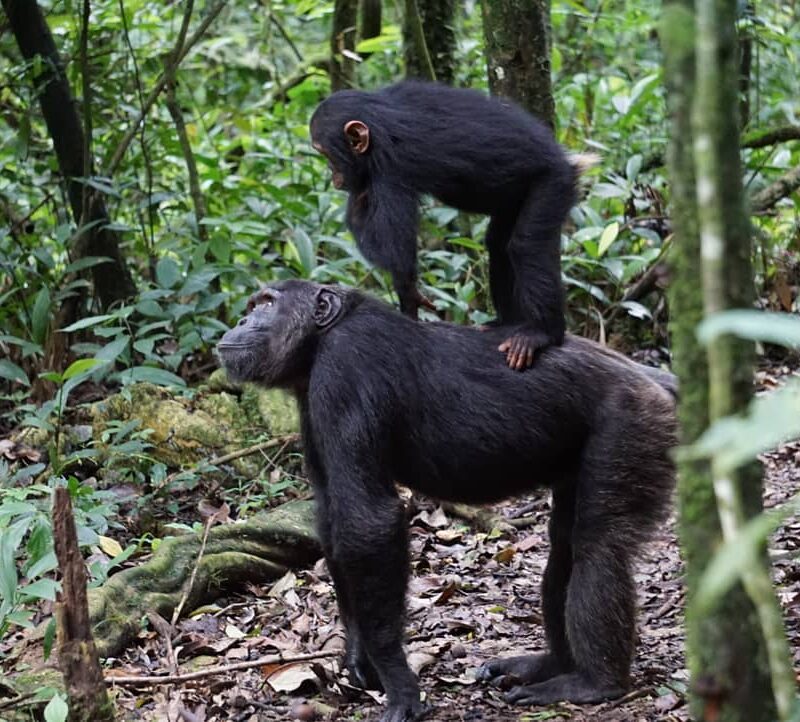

{"left": 347, "top": 180, "right": 434, "bottom": 318}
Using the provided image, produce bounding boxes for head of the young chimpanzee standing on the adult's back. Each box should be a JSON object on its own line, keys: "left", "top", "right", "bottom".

{"left": 310, "top": 90, "right": 374, "bottom": 191}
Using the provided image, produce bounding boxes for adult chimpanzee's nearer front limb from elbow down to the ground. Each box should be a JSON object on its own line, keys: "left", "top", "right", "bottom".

{"left": 328, "top": 477, "right": 428, "bottom": 722}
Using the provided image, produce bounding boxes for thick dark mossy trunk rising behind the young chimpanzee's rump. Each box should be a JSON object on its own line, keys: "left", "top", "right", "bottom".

{"left": 481, "top": 0, "right": 555, "bottom": 128}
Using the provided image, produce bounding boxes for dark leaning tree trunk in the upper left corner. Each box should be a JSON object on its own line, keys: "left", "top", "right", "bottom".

{"left": 2, "top": 0, "right": 136, "bottom": 307}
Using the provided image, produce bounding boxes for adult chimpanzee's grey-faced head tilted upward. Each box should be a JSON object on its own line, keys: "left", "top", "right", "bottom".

{"left": 217, "top": 281, "right": 347, "bottom": 387}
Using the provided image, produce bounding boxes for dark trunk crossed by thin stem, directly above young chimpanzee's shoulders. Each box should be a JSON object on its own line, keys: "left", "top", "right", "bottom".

{"left": 403, "top": 0, "right": 456, "bottom": 85}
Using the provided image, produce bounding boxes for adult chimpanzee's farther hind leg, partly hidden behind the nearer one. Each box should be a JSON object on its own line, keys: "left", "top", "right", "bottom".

{"left": 477, "top": 479, "right": 575, "bottom": 689}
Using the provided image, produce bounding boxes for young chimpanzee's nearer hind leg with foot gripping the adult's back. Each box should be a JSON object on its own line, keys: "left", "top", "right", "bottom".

{"left": 500, "top": 166, "right": 575, "bottom": 370}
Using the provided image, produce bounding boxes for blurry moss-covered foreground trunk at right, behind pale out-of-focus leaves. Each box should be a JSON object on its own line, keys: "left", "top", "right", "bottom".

{"left": 661, "top": 0, "right": 775, "bottom": 722}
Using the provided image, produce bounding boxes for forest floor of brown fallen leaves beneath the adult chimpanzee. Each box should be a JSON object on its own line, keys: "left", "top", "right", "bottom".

{"left": 95, "top": 372, "right": 800, "bottom": 722}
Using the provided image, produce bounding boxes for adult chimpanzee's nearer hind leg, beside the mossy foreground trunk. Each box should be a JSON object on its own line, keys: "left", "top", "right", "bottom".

{"left": 506, "top": 456, "right": 636, "bottom": 704}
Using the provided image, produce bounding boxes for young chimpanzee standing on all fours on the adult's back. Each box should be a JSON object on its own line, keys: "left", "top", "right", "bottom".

{"left": 311, "top": 81, "right": 578, "bottom": 369}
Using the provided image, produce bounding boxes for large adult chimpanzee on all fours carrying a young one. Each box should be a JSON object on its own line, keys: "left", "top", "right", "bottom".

{"left": 218, "top": 281, "right": 675, "bottom": 722}
